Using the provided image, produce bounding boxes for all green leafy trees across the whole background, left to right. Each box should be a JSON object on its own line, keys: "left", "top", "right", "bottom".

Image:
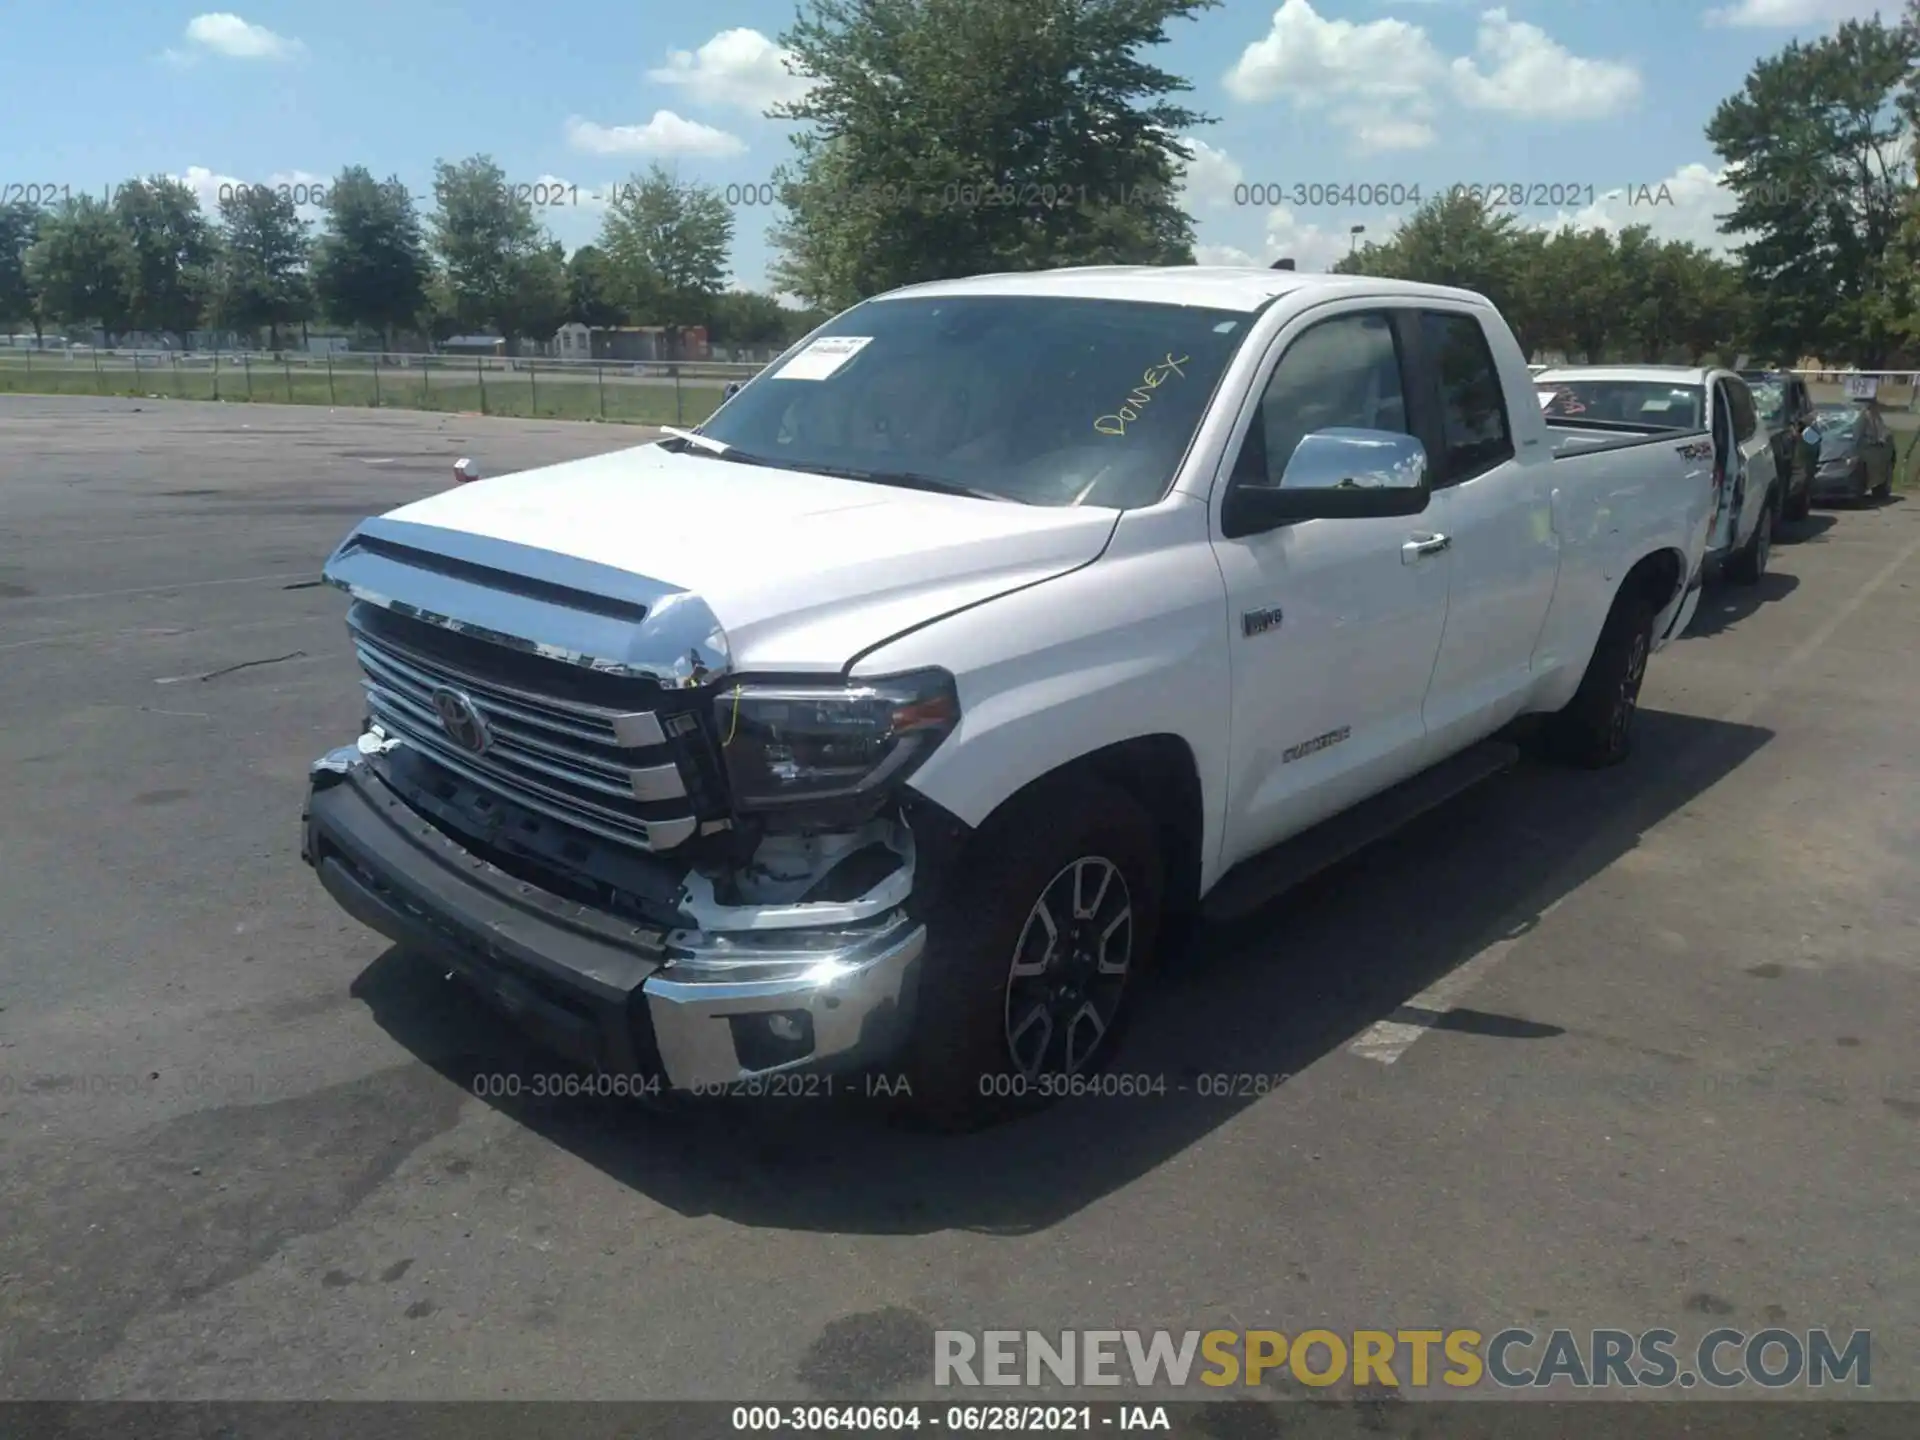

{"left": 0, "top": 0, "right": 1920, "bottom": 367}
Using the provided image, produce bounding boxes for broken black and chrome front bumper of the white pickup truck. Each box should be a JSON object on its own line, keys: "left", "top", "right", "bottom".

{"left": 301, "top": 749, "right": 925, "bottom": 1092}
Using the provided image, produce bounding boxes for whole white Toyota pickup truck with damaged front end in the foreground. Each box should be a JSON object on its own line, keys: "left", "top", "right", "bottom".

{"left": 303, "top": 267, "right": 1713, "bottom": 1123}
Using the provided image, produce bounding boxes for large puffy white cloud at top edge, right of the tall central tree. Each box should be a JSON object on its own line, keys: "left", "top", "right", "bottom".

{"left": 1225, "top": 0, "right": 1651, "bottom": 154}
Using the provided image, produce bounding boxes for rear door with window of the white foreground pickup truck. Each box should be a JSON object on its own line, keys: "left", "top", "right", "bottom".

{"left": 1419, "top": 309, "right": 1559, "bottom": 760}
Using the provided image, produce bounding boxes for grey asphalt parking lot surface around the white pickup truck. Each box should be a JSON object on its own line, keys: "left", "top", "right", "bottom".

{"left": 0, "top": 397, "right": 1920, "bottom": 1400}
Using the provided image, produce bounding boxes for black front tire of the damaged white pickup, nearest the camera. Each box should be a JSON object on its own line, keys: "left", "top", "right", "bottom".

{"left": 904, "top": 778, "right": 1165, "bottom": 1131}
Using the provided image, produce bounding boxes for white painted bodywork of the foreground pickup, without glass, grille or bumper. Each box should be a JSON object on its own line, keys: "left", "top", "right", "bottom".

{"left": 385, "top": 267, "right": 1712, "bottom": 891}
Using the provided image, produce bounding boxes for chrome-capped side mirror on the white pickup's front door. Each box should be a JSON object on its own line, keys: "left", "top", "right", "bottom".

{"left": 1221, "top": 428, "right": 1432, "bottom": 540}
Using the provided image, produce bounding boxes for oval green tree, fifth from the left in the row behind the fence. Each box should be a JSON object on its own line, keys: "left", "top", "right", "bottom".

{"left": 311, "top": 165, "right": 432, "bottom": 349}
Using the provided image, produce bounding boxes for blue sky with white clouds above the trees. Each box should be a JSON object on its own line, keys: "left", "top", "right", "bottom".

{"left": 0, "top": 0, "right": 1897, "bottom": 295}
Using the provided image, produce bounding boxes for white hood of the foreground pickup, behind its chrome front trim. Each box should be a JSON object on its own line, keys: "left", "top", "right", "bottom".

{"left": 357, "top": 445, "right": 1119, "bottom": 672}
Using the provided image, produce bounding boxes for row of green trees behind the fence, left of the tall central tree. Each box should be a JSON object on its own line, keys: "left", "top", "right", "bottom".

{"left": 0, "top": 156, "right": 818, "bottom": 349}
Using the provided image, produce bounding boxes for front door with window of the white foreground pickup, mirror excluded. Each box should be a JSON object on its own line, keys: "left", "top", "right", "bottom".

{"left": 1213, "top": 301, "right": 1452, "bottom": 868}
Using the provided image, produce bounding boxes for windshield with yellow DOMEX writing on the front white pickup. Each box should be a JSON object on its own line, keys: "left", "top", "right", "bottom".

{"left": 701, "top": 296, "right": 1252, "bottom": 509}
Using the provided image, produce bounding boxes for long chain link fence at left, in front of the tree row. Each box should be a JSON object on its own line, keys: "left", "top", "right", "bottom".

{"left": 0, "top": 348, "right": 762, "bottom": 424}
